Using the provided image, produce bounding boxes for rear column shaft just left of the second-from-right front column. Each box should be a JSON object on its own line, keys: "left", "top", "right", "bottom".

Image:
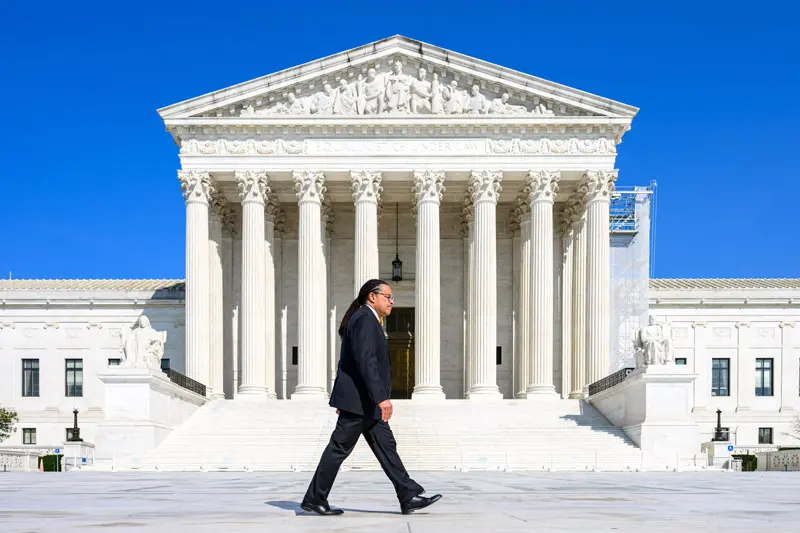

{"left": 516, "top": 208, "right": 532, "bottom": 398}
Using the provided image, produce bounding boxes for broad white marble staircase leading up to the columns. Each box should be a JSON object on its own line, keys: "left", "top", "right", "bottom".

{"left": 106, "top": 399, "right": 692, "bottom": 471}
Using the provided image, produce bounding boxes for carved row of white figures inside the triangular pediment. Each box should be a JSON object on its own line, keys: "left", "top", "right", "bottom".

{"left": 241, "top": 60, "right": 554, "bottom": 117}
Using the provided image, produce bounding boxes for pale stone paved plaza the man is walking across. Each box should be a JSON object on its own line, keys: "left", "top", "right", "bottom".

{"left": 0, "top": 472, "right": 800, "bottom": 533}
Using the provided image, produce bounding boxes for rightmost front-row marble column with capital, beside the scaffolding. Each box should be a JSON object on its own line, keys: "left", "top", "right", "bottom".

{"left": 582, "top": 170, "right": 617, "bottom": 385}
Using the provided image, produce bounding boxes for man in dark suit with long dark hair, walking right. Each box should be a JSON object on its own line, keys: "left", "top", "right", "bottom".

{"left": 301, "top": 279, "right": 441, "bottom": 515}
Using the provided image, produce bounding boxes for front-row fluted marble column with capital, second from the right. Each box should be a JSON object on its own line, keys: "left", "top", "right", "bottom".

{"left": 528, "top": 170, "right": 560, "bottom": 399}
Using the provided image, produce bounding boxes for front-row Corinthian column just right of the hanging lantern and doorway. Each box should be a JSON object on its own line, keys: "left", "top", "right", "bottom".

{"left": 411, "top": 170, "right": 444, "bottom": 400}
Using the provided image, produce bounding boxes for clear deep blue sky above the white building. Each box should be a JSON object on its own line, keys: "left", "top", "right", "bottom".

{"left": 0, "top": 0, "right": 800, "bottom": 278}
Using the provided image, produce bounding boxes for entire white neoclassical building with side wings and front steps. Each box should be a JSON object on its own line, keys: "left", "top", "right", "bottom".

{"left": 0, "top": 36, "right": 800, "bottom": 470}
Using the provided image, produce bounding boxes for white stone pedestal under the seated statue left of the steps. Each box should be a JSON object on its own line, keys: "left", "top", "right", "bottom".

{"left": 95, "top": 366, "right": 207, "bottom": 463}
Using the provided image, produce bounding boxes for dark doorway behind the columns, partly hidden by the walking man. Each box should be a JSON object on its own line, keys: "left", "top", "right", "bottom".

{"left": 383, "top": 307, "right": 414, "bottom": 400}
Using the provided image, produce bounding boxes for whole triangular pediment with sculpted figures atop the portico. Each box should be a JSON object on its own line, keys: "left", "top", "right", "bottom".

{"left": 159, "top": 36, "right": 638, "bottom": 120}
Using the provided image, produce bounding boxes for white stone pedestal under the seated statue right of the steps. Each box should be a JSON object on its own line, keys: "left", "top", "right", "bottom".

{"left": 588, "top": 363, "right": 700, "bottom": 459}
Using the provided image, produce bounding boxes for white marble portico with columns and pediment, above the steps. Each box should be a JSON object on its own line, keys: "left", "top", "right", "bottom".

{"left": 160, "top": 37, "right": 636, "bottom": 401}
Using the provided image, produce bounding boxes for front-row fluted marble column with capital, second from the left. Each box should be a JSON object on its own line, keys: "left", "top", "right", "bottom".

{"left": 235, "top": 170, "right": 269, "bottom": 397}
